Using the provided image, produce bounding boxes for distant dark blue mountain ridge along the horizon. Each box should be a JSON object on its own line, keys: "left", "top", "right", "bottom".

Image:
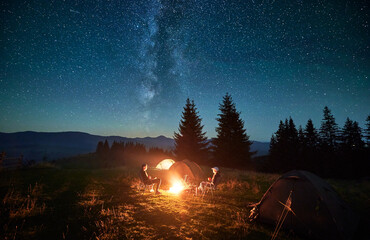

{"left": 0, "top": 131, "right": 269, "bottom": 161}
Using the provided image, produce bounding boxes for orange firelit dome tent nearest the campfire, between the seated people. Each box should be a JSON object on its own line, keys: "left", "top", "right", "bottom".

{"left": 169, "top": 159, "right": 204, "bottom": 182}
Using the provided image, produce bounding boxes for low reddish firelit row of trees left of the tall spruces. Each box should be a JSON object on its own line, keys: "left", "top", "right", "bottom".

{"left": 96, "top": 140, "right": 173, "bottom": 166}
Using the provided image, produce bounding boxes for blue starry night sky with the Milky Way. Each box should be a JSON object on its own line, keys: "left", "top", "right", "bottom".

{"left": 0, "top": 0, "right": 370, "bottom": 141}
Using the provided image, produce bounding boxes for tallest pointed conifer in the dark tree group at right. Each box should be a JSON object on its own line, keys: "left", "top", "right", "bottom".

{"left": 320, "top": 106, "right": 338, "bottom": 151}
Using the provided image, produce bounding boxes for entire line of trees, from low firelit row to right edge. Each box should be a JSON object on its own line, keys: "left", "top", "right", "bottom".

{"left": 96, "top": 93, "right": 370, "bottom": 178}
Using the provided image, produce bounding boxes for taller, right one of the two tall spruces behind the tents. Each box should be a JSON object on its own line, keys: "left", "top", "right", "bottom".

{"left": 213, "top": 93, "right": 253, "bottom": 168}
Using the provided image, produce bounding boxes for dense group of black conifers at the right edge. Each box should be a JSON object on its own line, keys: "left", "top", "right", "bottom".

{"left": 264, "top": 107, "right": 370, "bottom": 178}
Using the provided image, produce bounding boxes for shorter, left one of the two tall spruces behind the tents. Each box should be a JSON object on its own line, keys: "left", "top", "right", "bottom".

{"left": 174, "top": 98, "right": 209, "bottom": 164}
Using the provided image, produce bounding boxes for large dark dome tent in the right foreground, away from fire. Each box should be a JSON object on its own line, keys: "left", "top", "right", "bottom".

{"left": 251, "top": 170, "right": 358, "bottom": 240}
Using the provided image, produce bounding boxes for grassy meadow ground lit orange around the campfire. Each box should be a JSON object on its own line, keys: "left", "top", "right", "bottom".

{"left": 0, "top": 165, "right": 370, "bottom": 239}
